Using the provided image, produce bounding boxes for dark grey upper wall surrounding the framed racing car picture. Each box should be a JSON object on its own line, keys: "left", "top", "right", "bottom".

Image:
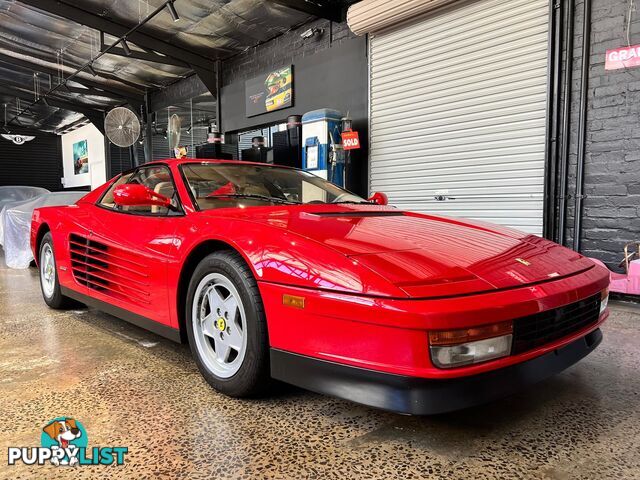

{"left": 221, "top": 20, "right": 368, "bottom": 195}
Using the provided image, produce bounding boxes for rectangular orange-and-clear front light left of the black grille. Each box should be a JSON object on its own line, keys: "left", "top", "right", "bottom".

{"left": 429, "top": 322, "right": 513, "bottom": 368}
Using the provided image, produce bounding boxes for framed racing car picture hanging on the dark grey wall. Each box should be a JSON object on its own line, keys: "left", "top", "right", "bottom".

{"left": 244, "top": 65, "right": 293, "bottom": 117}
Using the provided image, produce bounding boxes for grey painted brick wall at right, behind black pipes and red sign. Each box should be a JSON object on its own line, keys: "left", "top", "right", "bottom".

{"left": 567, "top": 0, "right": 640, "bottom": 270}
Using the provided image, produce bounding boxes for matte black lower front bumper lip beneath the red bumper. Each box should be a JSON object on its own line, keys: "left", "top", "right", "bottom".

{"left": 271, "top": 329, "right": 602, "bottom": 415}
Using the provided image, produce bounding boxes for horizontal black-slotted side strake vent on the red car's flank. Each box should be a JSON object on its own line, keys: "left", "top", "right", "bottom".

{"left": 69, "top": 234, "right": 149, "bottom": 305}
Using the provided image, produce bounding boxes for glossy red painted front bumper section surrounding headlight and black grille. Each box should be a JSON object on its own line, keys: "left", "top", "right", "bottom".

{"left": 259, "top": 262, "right": 609, "bottom": 380}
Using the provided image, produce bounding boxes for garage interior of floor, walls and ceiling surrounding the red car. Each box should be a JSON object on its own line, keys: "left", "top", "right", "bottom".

{"left": 0, "top": 0, "right": 640, "bottom": 479}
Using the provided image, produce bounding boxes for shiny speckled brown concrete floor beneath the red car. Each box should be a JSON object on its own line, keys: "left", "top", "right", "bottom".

{"left": 0, "top": 260, "right": 640, "bottom": 479}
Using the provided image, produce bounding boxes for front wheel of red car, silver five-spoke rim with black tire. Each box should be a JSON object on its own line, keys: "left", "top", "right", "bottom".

{"left": 186, "top": 251, "right": 269, "bottom": 397}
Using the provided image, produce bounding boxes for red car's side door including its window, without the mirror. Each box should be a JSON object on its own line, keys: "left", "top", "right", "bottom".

{"left": 87, "top": 165, "right": 183, "bottom": 328}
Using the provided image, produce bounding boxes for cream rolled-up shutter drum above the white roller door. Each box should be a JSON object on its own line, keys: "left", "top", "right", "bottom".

{"left": 347, "top": 0, "right": 455, "bottom": 35}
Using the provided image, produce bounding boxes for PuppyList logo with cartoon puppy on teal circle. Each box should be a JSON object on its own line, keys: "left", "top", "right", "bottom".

{"left": 9, "top": 417, "right": 128, "bottom": 467}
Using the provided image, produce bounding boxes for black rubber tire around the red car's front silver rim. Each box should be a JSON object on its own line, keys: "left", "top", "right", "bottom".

{"left": 185, "top": 250, "right": 271, "bottom": 398}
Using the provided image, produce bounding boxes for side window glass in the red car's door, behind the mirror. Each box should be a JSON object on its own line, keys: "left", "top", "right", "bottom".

{"left": 100, "top": 166, "right": 177, "bottom": 216}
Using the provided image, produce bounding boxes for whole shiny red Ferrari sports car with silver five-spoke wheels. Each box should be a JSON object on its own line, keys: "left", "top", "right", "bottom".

{"left": 31, "top": 159, "right": 609, "bottom": 414}
